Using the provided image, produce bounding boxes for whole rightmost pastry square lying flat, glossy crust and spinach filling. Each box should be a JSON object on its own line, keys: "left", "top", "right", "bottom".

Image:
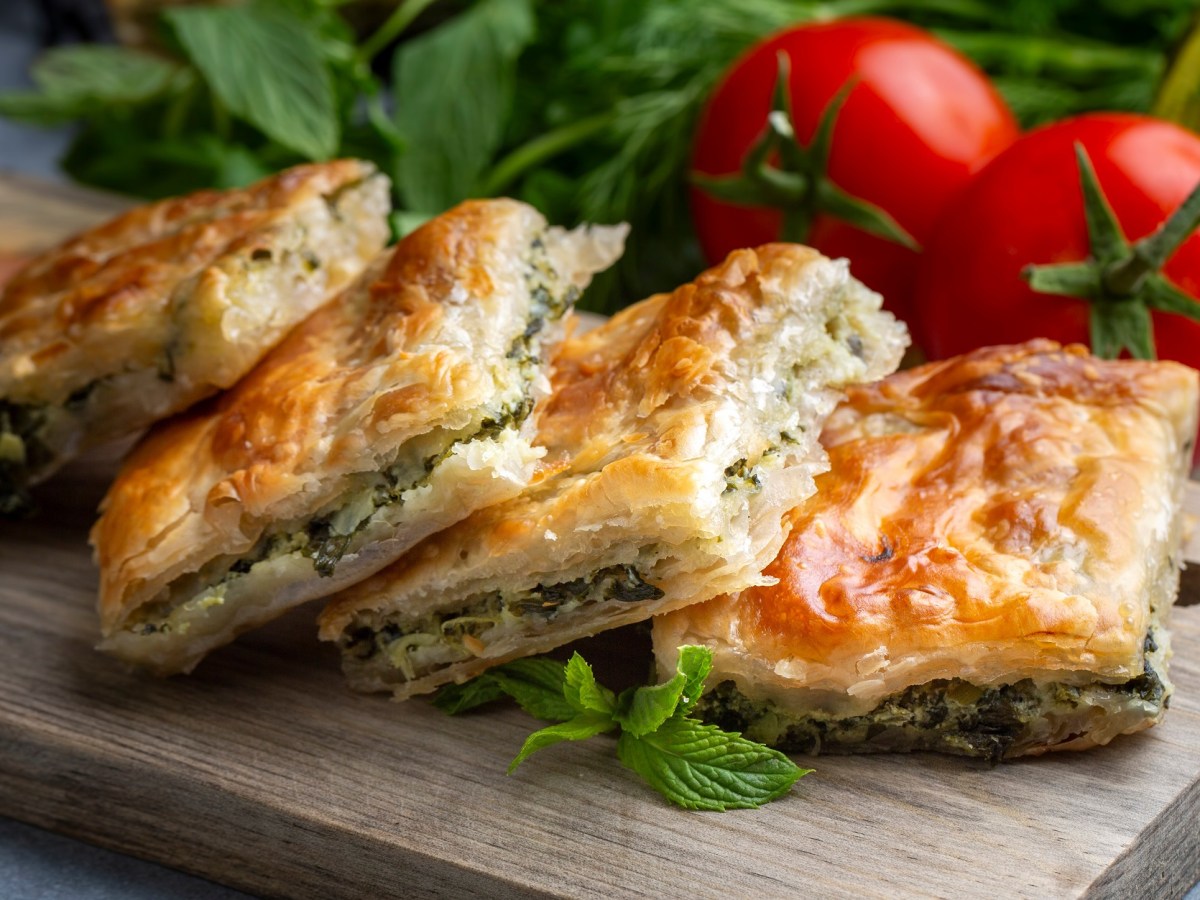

{"left": 654, "top": 341, "right": 1198, "bottom": 760}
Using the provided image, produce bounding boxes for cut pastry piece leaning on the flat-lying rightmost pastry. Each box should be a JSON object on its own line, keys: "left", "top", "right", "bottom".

{"left": 320, "top": 245, "right": 907, "bottom": 697}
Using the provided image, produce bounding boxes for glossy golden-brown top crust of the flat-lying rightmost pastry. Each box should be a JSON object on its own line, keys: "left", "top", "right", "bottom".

{"left": 655, "top": 341, "right": 1198, "bottom": 707}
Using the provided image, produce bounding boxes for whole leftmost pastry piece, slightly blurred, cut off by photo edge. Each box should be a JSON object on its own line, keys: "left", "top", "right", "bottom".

{"left": 0, "top": 160, "right": 389, "bottom": 514}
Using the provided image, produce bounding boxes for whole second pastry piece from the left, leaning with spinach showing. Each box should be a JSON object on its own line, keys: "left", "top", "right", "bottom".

{"left": 92, "top": 200, "right": 624, "bottom": 672}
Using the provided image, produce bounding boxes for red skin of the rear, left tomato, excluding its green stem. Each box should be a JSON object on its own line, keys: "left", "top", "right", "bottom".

{"left": 692, "top": 18, "right": 1018, "bottom": 338}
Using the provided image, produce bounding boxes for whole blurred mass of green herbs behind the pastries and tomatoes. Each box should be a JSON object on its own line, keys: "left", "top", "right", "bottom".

{"left": 0, "top": 0, "right": 1195, "bottom": 311}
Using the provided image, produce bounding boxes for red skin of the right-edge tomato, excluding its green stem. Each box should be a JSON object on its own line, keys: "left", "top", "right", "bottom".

{"left": 917, "top": 113, "right": 1200, "bottom": 367}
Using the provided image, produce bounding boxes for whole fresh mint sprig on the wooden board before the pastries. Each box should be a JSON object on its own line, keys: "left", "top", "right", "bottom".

{"left": 433, "top": 646, "right": 811, "bottom": 811}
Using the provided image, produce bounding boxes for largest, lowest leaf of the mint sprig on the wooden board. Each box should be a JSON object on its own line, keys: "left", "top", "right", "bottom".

{"left": 617, "top": 718, "right": 811, "bottom": 811}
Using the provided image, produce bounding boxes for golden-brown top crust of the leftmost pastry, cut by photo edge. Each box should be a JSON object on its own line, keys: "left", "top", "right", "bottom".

{"left": 0, "top": 160, "right": 385, "bottom": 408}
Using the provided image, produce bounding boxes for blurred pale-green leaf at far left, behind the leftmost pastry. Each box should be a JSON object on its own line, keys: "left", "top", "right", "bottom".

{"left": 0, "top": 44, "right": 192, "bottom": 125}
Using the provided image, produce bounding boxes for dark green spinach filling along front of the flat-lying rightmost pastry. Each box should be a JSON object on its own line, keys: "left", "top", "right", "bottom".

{"left": 696, "top": 631, "right": 1166, "bottom": 763}
